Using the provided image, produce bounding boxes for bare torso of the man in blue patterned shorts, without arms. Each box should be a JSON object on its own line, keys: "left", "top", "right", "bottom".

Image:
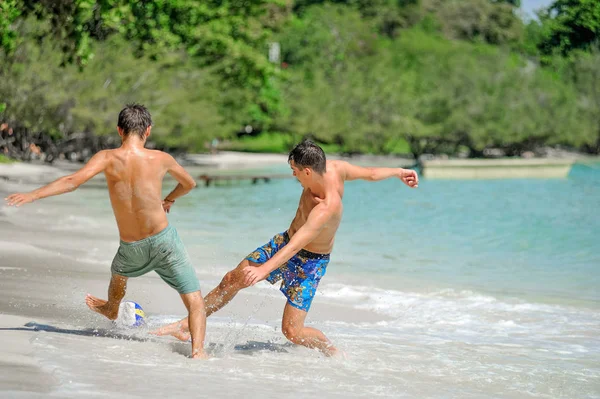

{"left": 288, "top": 161, "right": 344, "bottom": 254}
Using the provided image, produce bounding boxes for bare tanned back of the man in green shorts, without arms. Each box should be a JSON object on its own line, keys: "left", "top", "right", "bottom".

{"left": 104, "top": 147, "right": 169, "bottom": 242}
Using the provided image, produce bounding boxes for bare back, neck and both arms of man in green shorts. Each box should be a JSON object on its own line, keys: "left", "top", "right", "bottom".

{"left": 6, "top": 109, "right": 196, "bottom": 242}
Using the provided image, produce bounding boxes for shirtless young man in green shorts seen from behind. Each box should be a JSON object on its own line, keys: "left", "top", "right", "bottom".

{"left": 6, "top": 104, "right": 206, "bottom": 358}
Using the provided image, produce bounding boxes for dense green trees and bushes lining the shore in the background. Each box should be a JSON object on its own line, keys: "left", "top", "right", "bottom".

{"left": 0, "top": 0, "right": 600, "bottom": 156}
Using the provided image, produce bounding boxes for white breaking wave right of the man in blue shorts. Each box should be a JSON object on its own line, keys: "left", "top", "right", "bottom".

{"left": 319, "top": 284, "right": 600, "bottom": 336}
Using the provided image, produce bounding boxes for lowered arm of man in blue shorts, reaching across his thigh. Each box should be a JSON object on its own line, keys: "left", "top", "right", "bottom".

{"left": 244, "top": 205, "right": 332, "bottom": 285}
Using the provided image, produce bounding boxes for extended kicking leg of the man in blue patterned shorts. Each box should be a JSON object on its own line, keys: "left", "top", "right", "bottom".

{"left": 150, "top": 259, "right": 260, "bottom": 341}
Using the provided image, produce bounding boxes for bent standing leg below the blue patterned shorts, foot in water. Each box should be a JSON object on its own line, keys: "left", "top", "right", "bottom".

{"left": 281, "top": 302, "right": 337, "bottom": 356}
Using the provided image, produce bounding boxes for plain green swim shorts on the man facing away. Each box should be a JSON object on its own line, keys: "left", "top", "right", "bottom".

{"left": 111, "top": 225, "right": 200, "bottom": 294}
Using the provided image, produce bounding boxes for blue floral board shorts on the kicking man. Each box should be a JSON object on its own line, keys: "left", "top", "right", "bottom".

{"left": 246, "top": 231, "right": 329, "bottom": 312}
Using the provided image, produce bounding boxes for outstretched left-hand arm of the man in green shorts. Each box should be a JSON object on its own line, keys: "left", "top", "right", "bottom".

{"left": 5, "top": 151, "right": 107, "bottom": 207}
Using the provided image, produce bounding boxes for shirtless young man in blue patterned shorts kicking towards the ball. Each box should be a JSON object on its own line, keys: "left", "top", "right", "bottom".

{"left": 153, "top": 141, "right": 418, "bottom": 356}
